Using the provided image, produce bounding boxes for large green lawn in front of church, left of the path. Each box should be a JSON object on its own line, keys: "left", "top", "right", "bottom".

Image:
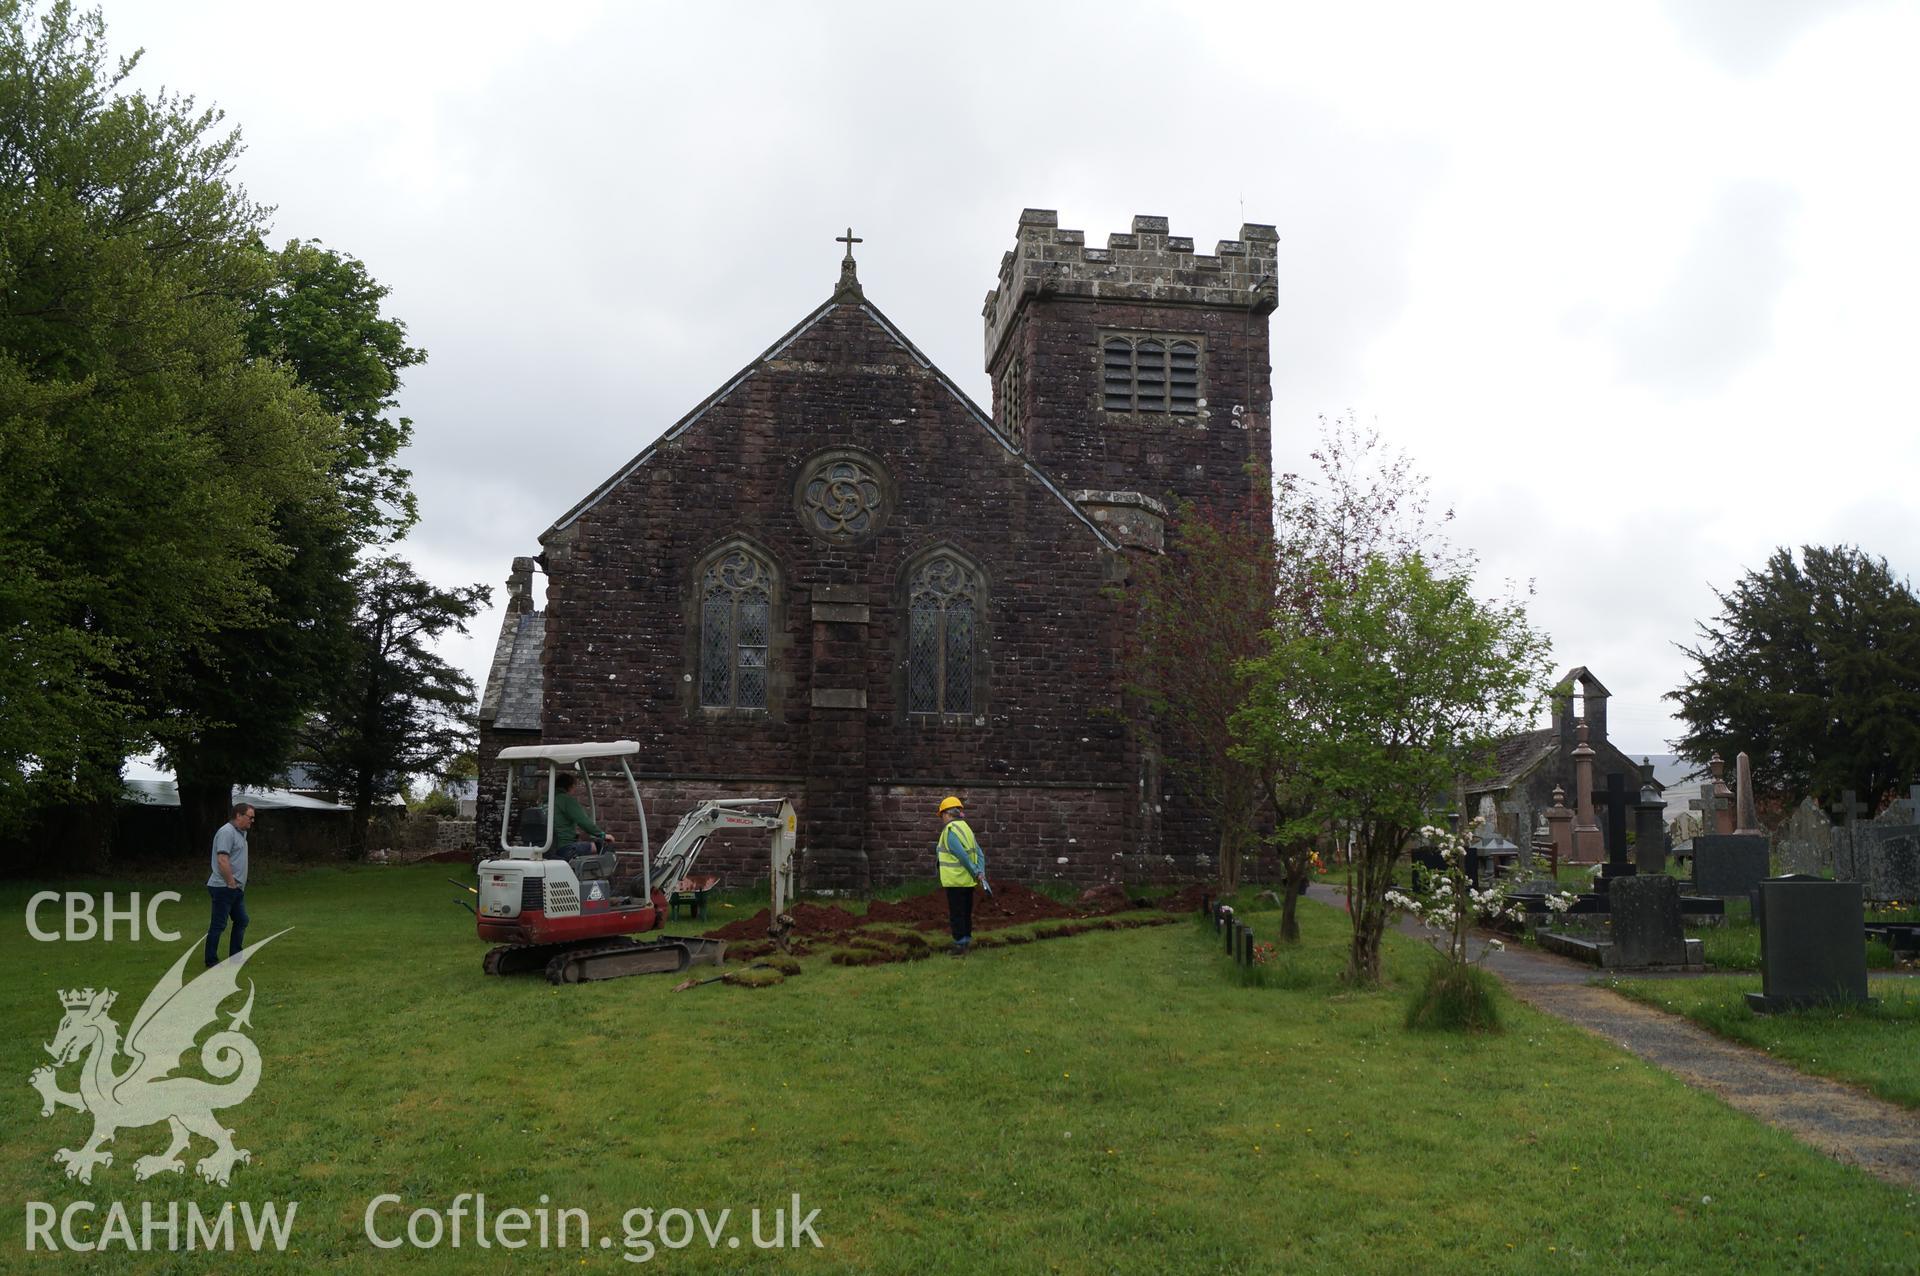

{"left": 0, "top": 865, "right": 1920, "bottom": 1272}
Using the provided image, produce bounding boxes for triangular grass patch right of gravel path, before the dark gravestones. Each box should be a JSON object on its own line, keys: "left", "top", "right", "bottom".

{"left": 1613, "top": 975, "right": 1920, "bottom": 1107}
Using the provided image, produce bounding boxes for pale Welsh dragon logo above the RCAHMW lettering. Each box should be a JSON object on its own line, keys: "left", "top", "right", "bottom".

{"left": 27, "top": 931, "right": 286, "bottom": 1188}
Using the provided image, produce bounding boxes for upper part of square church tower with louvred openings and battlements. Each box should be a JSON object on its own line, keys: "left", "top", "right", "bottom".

{"left": 983, "top": 209, "right": 1279, "bottom": 525}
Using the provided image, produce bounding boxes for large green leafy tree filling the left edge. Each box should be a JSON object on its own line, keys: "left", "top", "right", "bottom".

{"left": 0, "top": 0, "right": 342, "bottom": 832}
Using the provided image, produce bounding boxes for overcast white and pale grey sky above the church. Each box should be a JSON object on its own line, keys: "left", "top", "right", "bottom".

{"left": 104, "top": 0, "right": 1920, "bottom": 752}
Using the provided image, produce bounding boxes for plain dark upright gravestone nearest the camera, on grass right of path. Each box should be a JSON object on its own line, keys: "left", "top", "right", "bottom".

{"left": 1747, "top": 875, "right": 1866, "bottom": 1015}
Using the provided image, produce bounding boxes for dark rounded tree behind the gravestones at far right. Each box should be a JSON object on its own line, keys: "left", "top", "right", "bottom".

{"left": 1667, "top": 545, "right": 1920, "bottom": 806}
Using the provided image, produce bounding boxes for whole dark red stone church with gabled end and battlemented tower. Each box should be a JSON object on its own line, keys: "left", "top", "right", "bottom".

{"left": 478, "top": 209, "right": 1279, "bottom": 890}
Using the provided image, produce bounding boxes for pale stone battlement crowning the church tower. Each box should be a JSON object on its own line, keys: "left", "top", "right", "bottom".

{"left": 981, "top": 209, "right": 1281, "bottom": 366}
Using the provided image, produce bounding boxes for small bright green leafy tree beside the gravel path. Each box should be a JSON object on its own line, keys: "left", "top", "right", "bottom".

{"left": 1235, "top": 553, "right": 1548, "bottom": 984}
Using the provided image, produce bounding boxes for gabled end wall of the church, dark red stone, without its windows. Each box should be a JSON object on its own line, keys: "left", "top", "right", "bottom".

{"left": 529, "top": 305, "right": 1135, "bottom": 890}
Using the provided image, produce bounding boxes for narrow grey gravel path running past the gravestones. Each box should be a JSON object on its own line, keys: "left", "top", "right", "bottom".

{"left": 1308, "top": 885, "right": 1920, "bottom": 1188}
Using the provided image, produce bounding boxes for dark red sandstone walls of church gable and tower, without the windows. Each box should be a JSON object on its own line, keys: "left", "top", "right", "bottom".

{"left": 482, "top": 219, "right": 1271, "bottom": 890}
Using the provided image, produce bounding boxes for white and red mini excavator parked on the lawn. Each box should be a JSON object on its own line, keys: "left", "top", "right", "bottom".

{"left": 474, "top": 741, "right": 797, "bottom": 984}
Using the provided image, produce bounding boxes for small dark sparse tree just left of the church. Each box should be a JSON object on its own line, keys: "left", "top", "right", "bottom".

{"left": 309, "top": 558, "right": 492, "bottom": 860}
